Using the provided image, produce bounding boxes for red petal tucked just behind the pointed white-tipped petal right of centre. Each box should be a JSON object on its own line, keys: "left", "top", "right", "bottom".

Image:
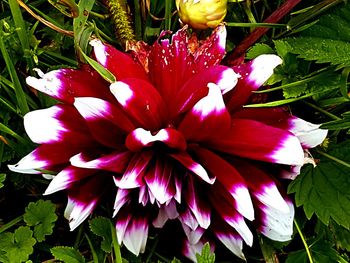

{"left": 174, "top": 65, "right": 238, "bottom": 114}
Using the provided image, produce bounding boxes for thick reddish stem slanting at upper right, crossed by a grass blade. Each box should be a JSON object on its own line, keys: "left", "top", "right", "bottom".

{"left": 226, "top": 0, "right": 301, "bottom": 65}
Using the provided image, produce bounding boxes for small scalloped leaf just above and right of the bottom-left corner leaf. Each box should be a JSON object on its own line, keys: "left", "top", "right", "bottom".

{"left": 23, "top": 200, "right": 57, "bottom": 242}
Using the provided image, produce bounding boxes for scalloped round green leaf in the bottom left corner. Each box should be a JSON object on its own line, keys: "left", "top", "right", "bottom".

{"left": 0, "top": 226, "right": 36, "bottom": 263}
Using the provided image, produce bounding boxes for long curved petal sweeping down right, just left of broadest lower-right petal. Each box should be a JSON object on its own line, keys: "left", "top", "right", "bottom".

{"left": 193, "top": 147, "right": 254, "bottom": 220}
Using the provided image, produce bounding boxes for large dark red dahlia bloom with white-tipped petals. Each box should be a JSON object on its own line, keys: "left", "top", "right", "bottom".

{"left": 10, "top": 26, "right": 327, "bottom": 260}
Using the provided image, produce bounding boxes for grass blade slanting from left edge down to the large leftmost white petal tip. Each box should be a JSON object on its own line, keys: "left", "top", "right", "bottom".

{"left": 0, "top": 26, "right": 29, "bottom": 115}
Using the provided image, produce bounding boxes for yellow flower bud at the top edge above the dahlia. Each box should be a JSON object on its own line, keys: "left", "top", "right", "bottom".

{"left": 176, "top": 0, "right": 227, "bottom": 29}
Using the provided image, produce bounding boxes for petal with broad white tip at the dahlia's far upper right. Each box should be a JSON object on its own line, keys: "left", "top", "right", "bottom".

{"left": 225, "top": 54, "right": 282, "bottom": 112}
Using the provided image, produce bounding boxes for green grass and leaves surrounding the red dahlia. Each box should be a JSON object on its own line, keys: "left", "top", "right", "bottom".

{"left": 0, "top": 0, "right": 350, "bottom": 263}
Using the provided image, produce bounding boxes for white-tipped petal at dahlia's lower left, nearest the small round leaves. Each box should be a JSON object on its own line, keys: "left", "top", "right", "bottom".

{"left": 64, "top": 174, "right": 109, "bottom": 231}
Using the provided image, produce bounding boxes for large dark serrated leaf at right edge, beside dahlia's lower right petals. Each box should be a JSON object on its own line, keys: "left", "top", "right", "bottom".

{"left": 288, "top": 141, "right": 350, "bottom": 229}
